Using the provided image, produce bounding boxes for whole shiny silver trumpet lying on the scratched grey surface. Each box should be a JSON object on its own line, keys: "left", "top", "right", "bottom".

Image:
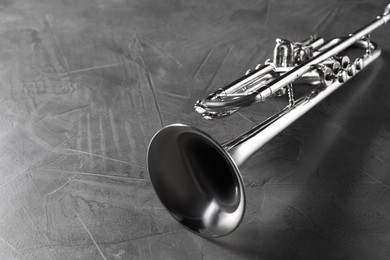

{"left": 147, "top": 4, "right": 390, "bottom": 237}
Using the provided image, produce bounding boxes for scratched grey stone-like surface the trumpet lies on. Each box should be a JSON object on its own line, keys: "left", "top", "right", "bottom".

{"left": 0, "top": 0, "right": 390, "bottom": 260}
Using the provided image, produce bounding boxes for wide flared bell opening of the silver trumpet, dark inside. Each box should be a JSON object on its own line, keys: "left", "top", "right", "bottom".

{"left": 147, "top": 124, "right": 245, "bottom": 237}
